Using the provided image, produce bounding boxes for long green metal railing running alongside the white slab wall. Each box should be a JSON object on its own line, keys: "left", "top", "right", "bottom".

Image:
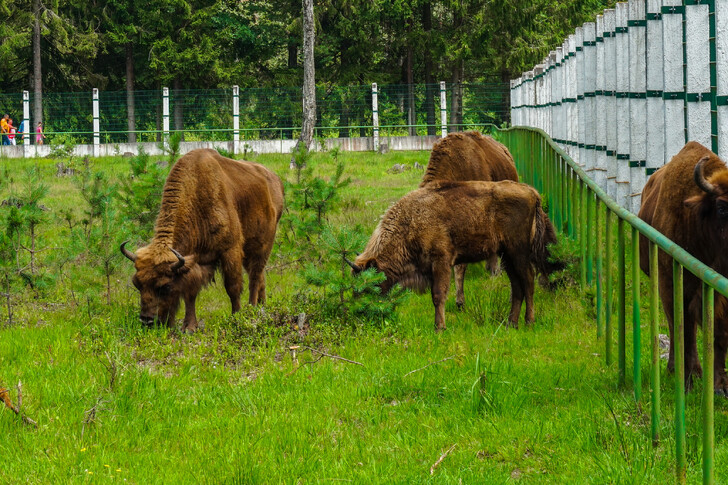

{"left": 498, "top": 127, "right": 728, "bottom": 484}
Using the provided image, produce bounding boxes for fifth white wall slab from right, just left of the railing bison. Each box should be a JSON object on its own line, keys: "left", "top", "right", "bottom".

{"left": 625, "top": 0, "right": 652, "bottom": 214}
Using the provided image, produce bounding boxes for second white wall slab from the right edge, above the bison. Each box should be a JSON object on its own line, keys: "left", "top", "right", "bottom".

{"left": 684, "top": 2, "right": 711, "bottom": 148}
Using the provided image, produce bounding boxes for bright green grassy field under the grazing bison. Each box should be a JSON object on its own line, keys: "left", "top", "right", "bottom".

{"left": 0, "top": 152, "right": 728, "bottom": 484}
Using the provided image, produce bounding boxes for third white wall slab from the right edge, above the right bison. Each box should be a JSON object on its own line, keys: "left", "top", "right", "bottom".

{"left": 661, "top": 0, "right": 687, "bottom": 163}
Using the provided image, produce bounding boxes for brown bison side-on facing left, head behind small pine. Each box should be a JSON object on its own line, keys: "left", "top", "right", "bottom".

{"left": 350, "top": 181, "right": 560, "bottom": 330}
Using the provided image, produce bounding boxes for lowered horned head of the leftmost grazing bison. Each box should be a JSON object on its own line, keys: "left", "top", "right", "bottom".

{"left": 121, "top": 241, "right": 194, "bottom": 325}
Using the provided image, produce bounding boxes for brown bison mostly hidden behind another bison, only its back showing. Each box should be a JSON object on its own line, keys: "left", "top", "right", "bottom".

{"left": 420, "top": 131, "right": 518, "bottom": 307}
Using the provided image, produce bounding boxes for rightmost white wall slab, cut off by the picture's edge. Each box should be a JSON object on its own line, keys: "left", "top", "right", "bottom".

{"left": 712, "top": 0, "right": 728, "bottom": 160}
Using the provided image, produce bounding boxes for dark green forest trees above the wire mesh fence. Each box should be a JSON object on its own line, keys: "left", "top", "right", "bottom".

{"left": 0, "top": 0, "right": 615, "bottom": 125}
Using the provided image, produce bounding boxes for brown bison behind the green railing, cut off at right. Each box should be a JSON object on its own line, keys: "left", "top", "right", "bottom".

{"left": 639, "top": 142, "right": 728, "bottom": 396}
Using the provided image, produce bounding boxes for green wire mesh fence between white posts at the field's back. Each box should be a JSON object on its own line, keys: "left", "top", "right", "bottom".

{"left": 0, "top": 83, "right": 510, "bottom": 144}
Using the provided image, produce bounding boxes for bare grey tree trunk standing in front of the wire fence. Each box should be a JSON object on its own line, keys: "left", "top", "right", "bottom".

{"left": 291, "top": 0, "right": 316, "bottom": 168}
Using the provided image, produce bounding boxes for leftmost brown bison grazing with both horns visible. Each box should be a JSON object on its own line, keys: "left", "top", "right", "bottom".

{"left": 121, "top": 149, "right": 283, "bottom": 332}
